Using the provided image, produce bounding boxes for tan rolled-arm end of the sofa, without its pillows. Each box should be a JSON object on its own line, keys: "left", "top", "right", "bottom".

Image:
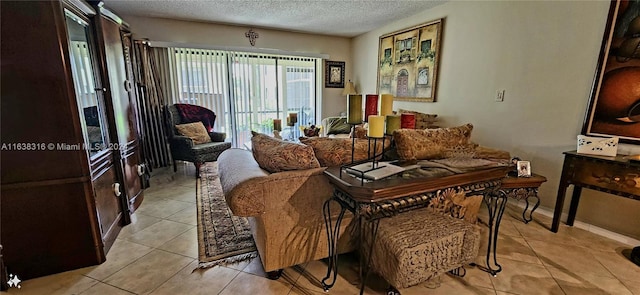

{"left": 218, "top": 149, "right": 355, "bottom": 278}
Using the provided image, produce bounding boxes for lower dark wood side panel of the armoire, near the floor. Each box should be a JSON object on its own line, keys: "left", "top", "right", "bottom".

{"left": 0, "top": 182, "right": 105, "bottom": 280}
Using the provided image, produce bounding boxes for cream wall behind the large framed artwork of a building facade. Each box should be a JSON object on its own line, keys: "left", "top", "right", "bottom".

{"left": 352, "top": 1, "right": 640, "bottom": 239}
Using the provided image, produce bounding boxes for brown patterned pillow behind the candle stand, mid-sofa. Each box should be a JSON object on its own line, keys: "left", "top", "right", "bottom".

{"left": 300, "top": 137, "right": 391, "bottom": 167}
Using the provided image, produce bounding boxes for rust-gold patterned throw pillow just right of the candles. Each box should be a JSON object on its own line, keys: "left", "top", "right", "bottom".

{"left": 393, "top": 124, "right": 473, "bottom": 160}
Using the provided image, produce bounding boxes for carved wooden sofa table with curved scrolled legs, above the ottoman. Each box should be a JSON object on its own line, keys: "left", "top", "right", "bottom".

{"left": 322, "top": 166, "right": 513, "bottom": 294}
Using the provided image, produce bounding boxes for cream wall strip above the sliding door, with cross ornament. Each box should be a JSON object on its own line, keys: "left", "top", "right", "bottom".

{"left": 117, "top": 12, "right": 353, "bottom": 118}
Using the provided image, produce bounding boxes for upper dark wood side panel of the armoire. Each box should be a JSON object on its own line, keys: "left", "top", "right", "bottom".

{"left": 0, "top": 1, "right": 89, "bottom": 184}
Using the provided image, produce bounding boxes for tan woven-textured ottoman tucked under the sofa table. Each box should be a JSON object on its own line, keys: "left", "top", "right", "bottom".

{"left": 364, "top": 208, "right": 480, "bottom": 289}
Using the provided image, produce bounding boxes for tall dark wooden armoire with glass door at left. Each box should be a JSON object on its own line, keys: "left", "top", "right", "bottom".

{"left": 0, "top": 0, "right": 144, "bottom": 280}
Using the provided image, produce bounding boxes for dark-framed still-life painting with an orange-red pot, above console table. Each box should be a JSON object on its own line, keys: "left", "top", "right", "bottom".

{"left": 582, "top": 0, "right": 640, "bottom": 144}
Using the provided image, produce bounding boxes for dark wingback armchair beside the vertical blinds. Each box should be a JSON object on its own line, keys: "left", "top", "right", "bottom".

{"left": 166, "top": 104, "right": 231, "bottom": 177}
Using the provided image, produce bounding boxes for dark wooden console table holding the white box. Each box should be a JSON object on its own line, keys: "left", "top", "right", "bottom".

{"left": 551, "top": 151, "right": 640, "bottom": 233}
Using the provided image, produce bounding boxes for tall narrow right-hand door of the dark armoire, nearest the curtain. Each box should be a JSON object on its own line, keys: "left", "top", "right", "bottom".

{"left": 100, "top": 12, "right": 143, "bottom": 218}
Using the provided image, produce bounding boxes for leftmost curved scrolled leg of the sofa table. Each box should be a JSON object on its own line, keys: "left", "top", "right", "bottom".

{"left": 322, "top": 197, "right": 346, "bottom": 292}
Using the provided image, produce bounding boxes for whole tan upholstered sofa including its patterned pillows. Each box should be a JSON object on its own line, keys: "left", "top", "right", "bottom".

{"left": 218, "top": 124, "right": 509, "bottom": 278}
